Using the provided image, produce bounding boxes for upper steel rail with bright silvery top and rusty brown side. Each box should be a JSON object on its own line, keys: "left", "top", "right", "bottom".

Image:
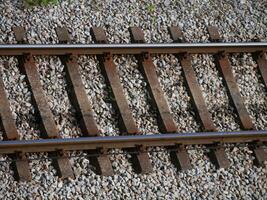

{"left": 0, "top": 42, "right": 267, "bottom": 56}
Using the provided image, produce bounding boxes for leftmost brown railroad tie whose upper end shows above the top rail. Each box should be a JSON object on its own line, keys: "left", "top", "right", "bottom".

{"left": 13, "top": 27, "right": 74, "bottom": 178}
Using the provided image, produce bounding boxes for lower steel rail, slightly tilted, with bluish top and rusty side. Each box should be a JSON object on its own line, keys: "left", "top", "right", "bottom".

{"left": 0, "top": 130, "right": 267, "bottom": 154}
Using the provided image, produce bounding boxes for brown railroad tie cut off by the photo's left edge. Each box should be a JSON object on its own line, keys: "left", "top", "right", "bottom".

{"left": 0, "top": 72, "right": 31, "bottom": 181}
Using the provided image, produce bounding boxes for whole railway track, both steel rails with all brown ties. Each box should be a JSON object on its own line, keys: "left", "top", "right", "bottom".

{"left": 0, "top": 26, "right": 267, "bottom": 180}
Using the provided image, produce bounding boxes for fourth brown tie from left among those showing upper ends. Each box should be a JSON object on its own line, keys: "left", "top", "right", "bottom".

{"left": 129, "top": 27, "right": 195, "bottom": 170}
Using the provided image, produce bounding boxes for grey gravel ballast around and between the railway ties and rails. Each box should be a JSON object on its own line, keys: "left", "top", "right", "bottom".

{"left": 0, "top": 0, "right": 267, "bottom": 200}
